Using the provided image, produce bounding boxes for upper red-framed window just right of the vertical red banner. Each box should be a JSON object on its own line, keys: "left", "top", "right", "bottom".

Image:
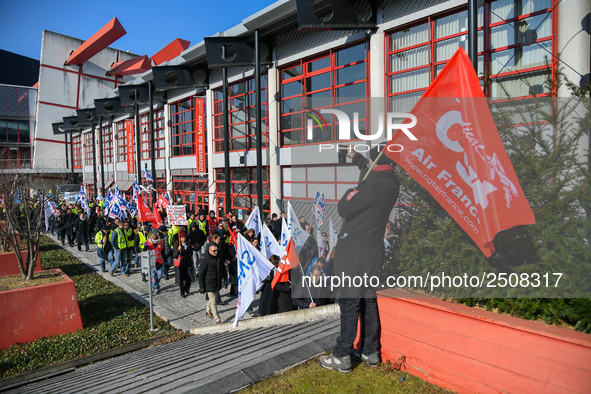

{"left": 214, "top": 75, "right": 269, "bottom": 152}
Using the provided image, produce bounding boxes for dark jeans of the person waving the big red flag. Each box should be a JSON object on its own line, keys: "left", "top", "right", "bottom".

{"left": 333, "top": 298, "right": 380, "bottom": 357}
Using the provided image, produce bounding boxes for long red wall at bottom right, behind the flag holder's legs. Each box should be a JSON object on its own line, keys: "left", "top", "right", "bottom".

{"left": 378, "top": 290, "right": 591, "bottom": 393}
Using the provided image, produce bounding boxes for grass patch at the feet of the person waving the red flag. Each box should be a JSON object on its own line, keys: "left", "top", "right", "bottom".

{"left": 241, "top": 358, "right": 448, "bottom": 393}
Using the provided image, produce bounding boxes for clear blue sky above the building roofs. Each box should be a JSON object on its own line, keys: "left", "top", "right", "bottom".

{"left": 0, "top": 0, "right": 276, "bottom": 60}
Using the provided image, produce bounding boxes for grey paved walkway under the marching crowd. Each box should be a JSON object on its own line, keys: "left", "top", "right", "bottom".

{"left": 46, "top": 233, "right": 259, "bottom": 332}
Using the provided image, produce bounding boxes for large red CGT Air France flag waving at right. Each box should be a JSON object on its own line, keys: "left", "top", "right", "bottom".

{"left": 384, "top": 48, "right": 535, "bottom": 257}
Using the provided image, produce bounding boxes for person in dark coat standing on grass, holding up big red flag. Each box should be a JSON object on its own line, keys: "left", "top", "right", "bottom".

{"left": 319, "top": 145, "right": 400, "bottom": 373}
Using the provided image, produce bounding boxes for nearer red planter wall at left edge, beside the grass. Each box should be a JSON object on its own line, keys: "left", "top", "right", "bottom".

{"left": 0, "top": 269, "right": 82, "bottom": 349}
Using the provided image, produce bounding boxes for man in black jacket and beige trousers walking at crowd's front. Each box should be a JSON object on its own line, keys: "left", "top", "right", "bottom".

{"left": 199, "top": 242, "right": 227, "bottom": 324}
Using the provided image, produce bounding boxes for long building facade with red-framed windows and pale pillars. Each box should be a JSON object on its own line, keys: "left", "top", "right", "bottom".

{"left": 35, "top": 0, "right": 590, "bottom": 225}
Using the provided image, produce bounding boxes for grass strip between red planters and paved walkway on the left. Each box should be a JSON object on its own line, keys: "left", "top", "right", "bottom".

{"left": 0, "top": 238, "right": 183, "bottom": 378}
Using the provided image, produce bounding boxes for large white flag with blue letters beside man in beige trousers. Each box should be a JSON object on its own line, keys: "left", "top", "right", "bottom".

{"left": 232, "top": 234, "right": 273, "bottom": 328}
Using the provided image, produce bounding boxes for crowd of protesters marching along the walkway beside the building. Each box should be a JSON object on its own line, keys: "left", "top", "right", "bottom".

{"left": 41, "top": 193, "right": 333, "bottom": 323}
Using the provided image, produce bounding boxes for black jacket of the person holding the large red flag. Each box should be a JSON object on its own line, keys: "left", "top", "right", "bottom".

{"left": 334, "top": 166, "right": 400, "bottom": 298}
